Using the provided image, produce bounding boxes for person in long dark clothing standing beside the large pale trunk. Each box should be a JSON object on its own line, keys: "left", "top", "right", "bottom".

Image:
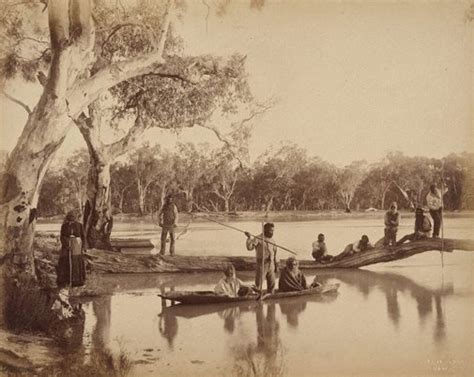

{"left": 56, "top": 221, "right": 86, "bottom": 288}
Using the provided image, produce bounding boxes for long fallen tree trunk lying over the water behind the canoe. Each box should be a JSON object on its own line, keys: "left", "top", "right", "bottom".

{"left": 82, "top": 238, "right": 474, "bottom": 273}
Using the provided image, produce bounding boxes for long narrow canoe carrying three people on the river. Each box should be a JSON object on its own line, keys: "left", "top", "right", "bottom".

{"left": 158, "top": 284, "right": 339, "bottom": 305}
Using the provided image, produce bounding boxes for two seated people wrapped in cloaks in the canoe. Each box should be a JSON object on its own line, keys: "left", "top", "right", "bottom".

{"left": 214, "top": 257, "right": 321, "bottom": 297}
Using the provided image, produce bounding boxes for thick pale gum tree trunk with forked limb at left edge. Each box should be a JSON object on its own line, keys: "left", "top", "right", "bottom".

{"left": 0, "top": 0, "right": 179, "bottom": 326}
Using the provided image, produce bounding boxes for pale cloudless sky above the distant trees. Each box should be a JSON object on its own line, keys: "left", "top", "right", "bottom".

{"left": 0, "top": 0, "right": 474, "bottom": 165}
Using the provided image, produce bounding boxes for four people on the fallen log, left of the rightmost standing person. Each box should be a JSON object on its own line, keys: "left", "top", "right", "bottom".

{"left": 312, "top": 202, "right": 431, "bottom": 263}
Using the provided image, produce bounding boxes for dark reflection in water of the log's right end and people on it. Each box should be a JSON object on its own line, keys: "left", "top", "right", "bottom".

{"left": 319, "top": 270, "right": 454, "bottom": 343}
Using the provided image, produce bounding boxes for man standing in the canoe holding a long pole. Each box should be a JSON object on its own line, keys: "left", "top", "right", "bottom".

{"left": 245, "top": 223, "right": 278, "bottom": 293}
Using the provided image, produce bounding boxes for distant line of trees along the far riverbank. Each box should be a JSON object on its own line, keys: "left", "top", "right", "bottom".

{"left": 38, "top": 143, "right": 474, "bottom": 217}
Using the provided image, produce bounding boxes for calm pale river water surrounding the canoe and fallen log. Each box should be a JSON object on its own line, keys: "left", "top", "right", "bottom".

{"left": 40, "top": 218, "right": 474, "bottom": 376}
